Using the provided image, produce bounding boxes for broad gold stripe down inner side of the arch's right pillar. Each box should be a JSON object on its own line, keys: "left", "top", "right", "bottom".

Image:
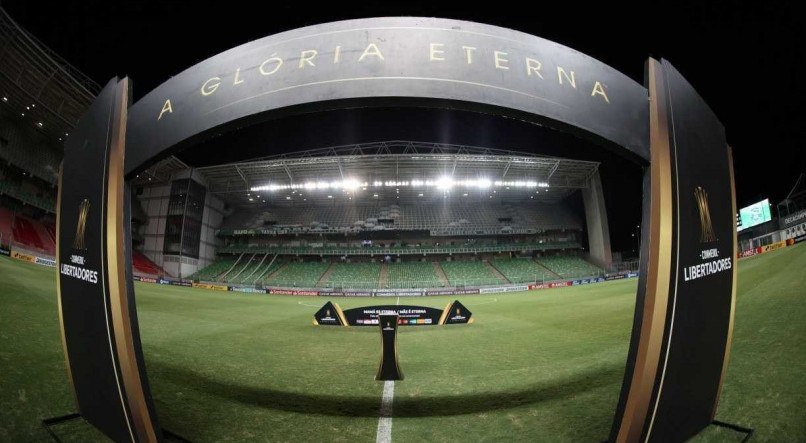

{"left": 616, "top": 58, "right": 673, "bottom": 442}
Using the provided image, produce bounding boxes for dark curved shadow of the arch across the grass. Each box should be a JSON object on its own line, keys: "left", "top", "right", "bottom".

{"left": 148, "top": 361, "right": 624, "bottom": 417}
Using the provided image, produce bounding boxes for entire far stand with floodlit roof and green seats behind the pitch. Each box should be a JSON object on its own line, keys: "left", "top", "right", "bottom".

{"left": 133, "top": 141, "right": 613, "bottom": 289}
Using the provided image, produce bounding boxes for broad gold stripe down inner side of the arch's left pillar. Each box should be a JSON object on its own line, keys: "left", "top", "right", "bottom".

{"left": 106, "top": 78, "right": 157, "bottom": 442}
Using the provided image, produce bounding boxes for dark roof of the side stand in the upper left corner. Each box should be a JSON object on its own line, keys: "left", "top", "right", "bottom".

{"left": 0, "top": 8, "right": 101, "bottom": 141}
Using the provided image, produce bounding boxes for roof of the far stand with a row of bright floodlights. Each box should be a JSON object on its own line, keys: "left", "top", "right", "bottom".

{"left": 198, "top": 140, "right": 599, "bottom": 206}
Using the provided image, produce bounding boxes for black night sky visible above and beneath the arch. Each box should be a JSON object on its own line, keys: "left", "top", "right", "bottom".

{"left": 2, "top": 0, "right": 806, "bottom": 253}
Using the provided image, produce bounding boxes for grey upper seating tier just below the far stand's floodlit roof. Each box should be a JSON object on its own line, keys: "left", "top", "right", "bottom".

{"left": 221, "top": 202, "right": 582, "bottom": 235}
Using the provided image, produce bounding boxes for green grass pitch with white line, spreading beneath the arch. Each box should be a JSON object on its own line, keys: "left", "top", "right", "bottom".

{"left": 0, "top": 246, "right": 806, "bottom": 441}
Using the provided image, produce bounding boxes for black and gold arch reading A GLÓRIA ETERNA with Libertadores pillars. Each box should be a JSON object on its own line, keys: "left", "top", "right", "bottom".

{"left": 57, "top": 17, "right": 736, "bottom": 441}
